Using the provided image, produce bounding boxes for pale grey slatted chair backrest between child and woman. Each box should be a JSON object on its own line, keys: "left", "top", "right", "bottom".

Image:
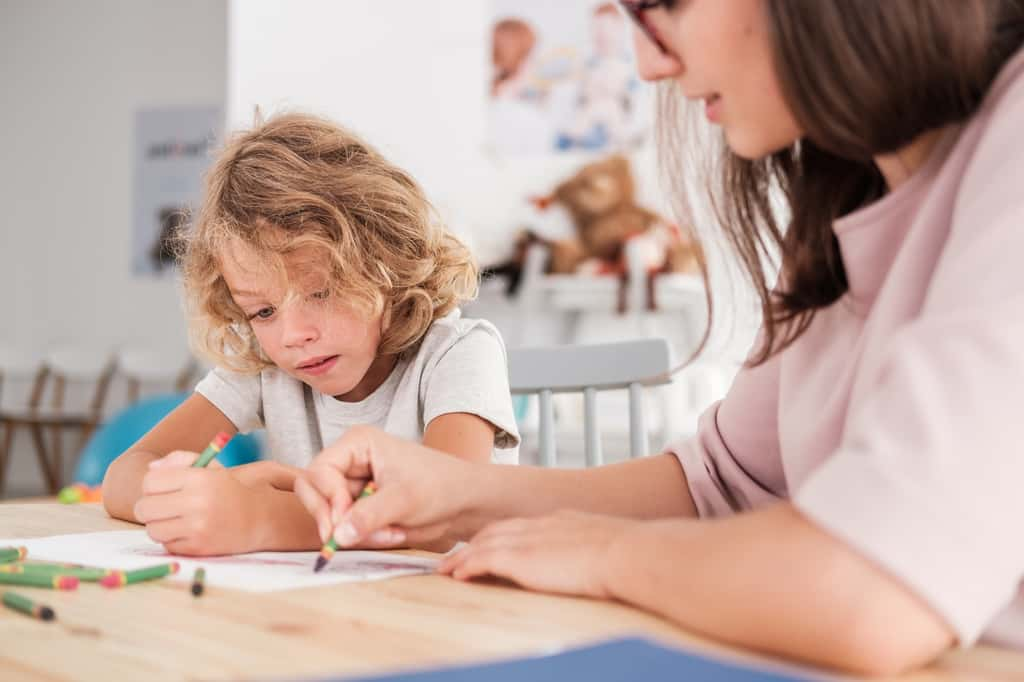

{"left": 509, "top": 339, "right": 672, "bottom": 466}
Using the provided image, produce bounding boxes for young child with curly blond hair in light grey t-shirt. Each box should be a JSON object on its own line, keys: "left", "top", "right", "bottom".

{"left": 103, "top": 115, "right": 519, "bottom": 555}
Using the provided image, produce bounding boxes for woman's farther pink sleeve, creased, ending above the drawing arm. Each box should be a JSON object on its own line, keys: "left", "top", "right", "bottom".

{"left": 668, "top": 337, "right": 785, "bottom": 517}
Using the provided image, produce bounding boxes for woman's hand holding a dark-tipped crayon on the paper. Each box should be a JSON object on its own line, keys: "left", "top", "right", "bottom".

{"left": 295, "top": 427, "right": 472, "bottom": 547}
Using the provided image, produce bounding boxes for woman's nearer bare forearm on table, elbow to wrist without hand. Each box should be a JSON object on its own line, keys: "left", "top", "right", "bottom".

{"left": 605, "top": 504, "right": 952, "bottom": 674}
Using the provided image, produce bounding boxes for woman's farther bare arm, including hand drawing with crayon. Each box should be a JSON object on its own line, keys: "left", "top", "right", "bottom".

{"left": 295, "top": 427, "right": 694, "bottom": 547}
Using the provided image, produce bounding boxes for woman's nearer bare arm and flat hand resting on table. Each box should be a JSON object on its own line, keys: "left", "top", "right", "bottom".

{"left": 440, "top": 503, "right": 954, "bottom": 675}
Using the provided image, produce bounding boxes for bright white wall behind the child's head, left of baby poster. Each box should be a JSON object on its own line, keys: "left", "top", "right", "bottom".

{"left": 227, "top": 0, "right": 671, "bottom": 270}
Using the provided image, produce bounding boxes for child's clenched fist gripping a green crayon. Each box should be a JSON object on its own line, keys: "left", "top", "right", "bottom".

{"left": 134, "top": 464, "right": 265, "bottom": 556}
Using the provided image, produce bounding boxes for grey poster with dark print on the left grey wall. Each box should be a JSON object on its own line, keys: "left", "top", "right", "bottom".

{"left": 132, "top": 106, "right": 222, "bottom": 276}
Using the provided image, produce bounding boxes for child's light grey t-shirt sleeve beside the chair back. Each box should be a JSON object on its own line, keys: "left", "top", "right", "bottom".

{"left": 423, "top": 325, "right": 519, "bottom": 450}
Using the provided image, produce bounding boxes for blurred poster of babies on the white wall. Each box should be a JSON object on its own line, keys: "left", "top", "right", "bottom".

{"left": 488, "top": 0, "right": 653, "bottom": 156}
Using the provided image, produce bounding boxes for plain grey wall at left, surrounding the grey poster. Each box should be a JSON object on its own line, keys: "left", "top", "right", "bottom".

{"left": 0, "top": 0, "right": 226, "bottom": 347}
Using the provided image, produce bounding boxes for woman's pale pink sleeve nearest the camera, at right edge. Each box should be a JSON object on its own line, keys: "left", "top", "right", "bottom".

{"left": 795, "top": 88, "right": 1024, "bottom": 646}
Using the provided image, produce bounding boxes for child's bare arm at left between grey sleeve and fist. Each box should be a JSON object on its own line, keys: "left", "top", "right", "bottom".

{"left": 103, "top": 393, "right": 237, "bottom": 523}
